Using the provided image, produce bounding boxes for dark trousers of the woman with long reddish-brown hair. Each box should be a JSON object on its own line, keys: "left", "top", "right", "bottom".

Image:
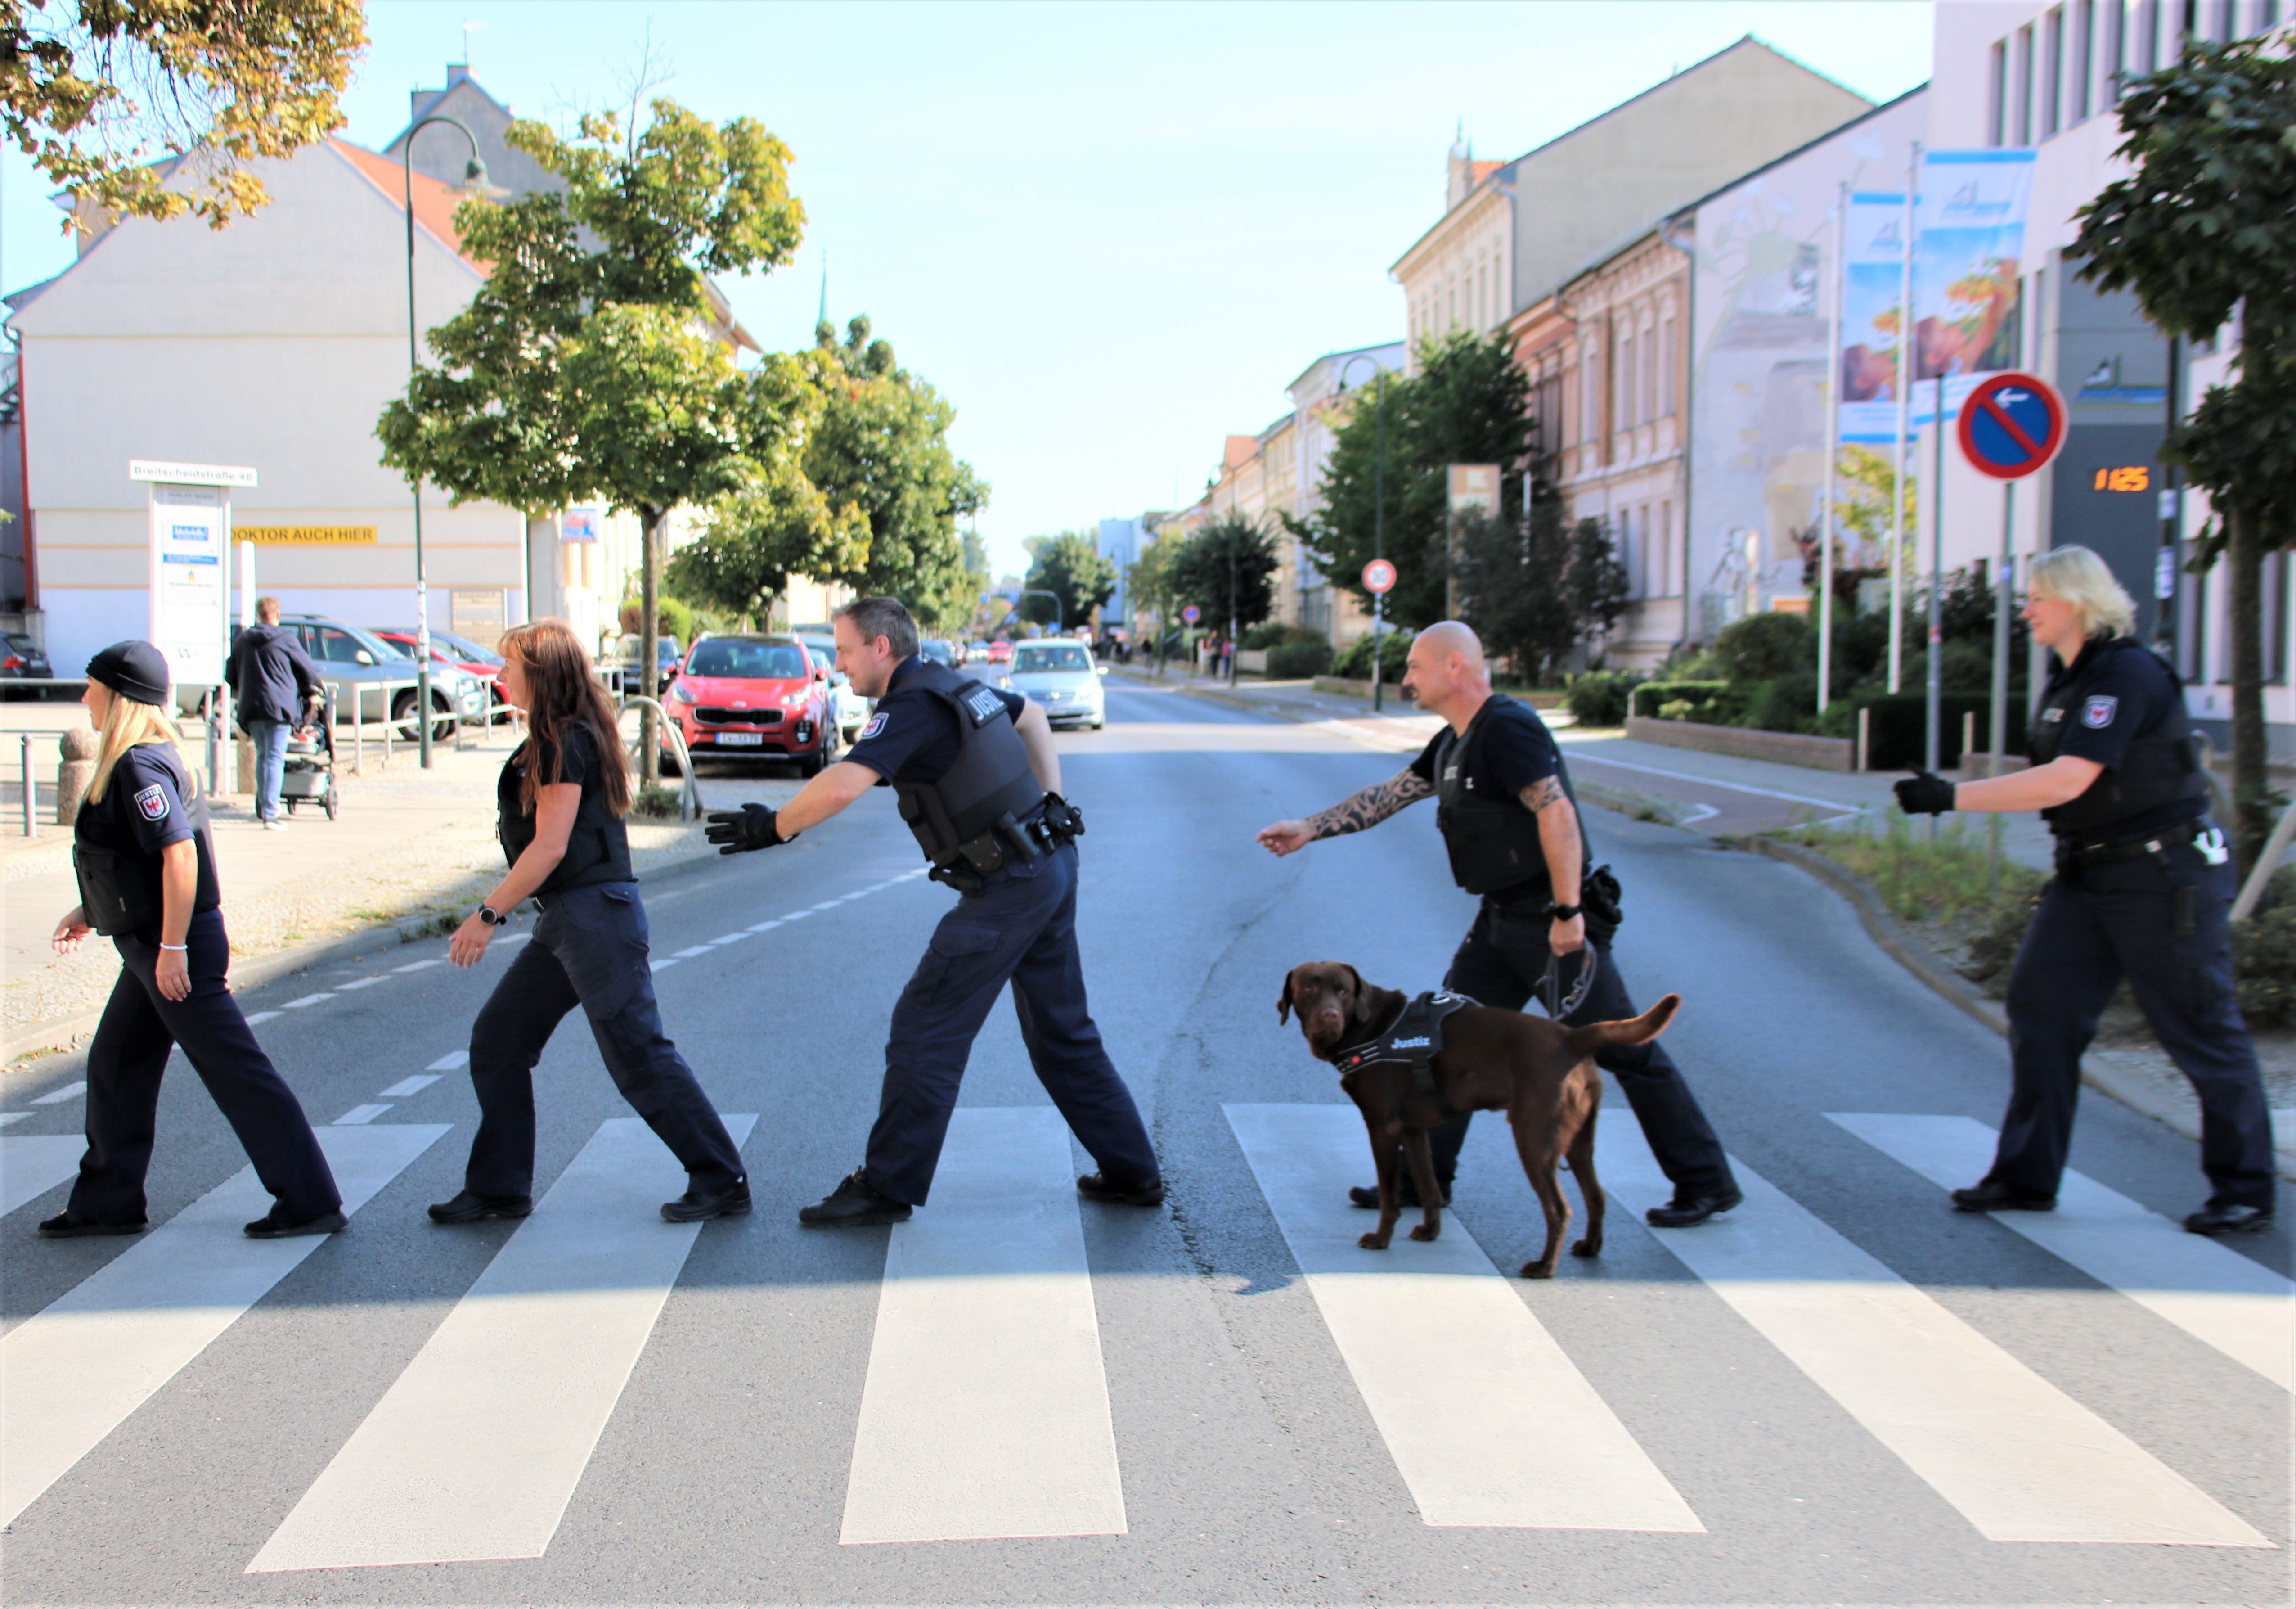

{"left": 464, "top": 883, "right": 749, "bottom": 1196}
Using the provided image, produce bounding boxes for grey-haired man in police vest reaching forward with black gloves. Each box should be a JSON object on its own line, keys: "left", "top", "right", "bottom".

{"left": 710, "top": 597, "right": 1164, "bottom": 1228}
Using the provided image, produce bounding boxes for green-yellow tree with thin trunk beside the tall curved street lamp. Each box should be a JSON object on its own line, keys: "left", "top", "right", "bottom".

{"left": 377, "top": 99, "right": 813, "bottom": 780}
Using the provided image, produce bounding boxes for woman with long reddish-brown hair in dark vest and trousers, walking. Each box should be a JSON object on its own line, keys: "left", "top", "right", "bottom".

{"left": 429, "top": 620, "right": 749, "bottom": 1223}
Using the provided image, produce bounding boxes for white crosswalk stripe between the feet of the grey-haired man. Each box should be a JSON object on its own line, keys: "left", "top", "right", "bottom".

{"left": 838, "top": 1106, "right": 1125, "bottom": 1542}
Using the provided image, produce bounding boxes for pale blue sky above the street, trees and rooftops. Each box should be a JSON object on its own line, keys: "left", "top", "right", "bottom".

{"left": 0, "top": 0, "right": 1929, "bottom": 569}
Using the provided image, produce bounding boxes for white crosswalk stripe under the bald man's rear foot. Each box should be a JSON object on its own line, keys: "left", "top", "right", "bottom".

{"left": 1596, "top": 1122, "right": 2273, "bottom": 1547}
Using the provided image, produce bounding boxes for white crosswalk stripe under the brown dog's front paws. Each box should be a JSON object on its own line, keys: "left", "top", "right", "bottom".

{"left": 1224, "top": 1106, "right": 1706, "bottom": 1531}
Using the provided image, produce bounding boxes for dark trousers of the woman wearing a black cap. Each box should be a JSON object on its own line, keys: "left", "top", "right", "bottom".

{"left": 69, "top": 911, "right": 342, "bottom": 1223}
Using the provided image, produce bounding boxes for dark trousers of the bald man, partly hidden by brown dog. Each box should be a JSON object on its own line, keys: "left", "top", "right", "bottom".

{"left": 1428, "top": 900, "right": 1736, "bottom": 1198}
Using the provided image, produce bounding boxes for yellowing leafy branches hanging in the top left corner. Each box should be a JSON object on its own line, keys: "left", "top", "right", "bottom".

{"left": 0, "top": 0, "right": 367, "bottom": 230}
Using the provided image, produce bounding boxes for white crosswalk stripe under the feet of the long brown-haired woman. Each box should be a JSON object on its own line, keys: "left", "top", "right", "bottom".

{"left": 248, "top": 1113, "right": 758, "bottom": 1575}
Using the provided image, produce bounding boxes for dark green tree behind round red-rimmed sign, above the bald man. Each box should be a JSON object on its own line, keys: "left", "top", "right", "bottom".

{"left": 1284, "top": 330, "right": 1532, "bottom": 626}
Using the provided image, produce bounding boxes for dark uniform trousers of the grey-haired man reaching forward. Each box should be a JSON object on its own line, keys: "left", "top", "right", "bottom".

{"left": 866, "top": 843, "right": 1159, "bottom": 1208}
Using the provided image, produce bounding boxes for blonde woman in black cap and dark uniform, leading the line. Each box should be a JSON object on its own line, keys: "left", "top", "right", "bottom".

{"left": 39, "top": 643, "right": 344, "bottom": 1239}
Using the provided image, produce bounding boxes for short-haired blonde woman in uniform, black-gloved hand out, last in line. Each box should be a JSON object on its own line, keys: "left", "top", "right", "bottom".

{"left": 1896, "top": 546, "right": 2275, "bottom": 1235}
